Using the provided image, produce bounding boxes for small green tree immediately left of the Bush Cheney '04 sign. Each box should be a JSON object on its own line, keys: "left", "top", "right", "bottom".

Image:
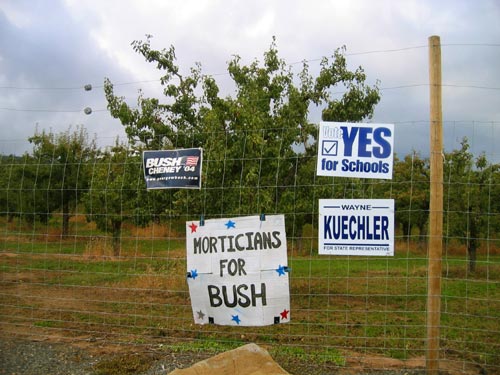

{"left": 83, "top": 142, "right": 149, "bottom": 256}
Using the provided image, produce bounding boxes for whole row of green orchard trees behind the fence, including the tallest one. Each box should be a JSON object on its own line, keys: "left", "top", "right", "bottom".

{"left": 0, "top": 37, "right": 500, "bottom": 274}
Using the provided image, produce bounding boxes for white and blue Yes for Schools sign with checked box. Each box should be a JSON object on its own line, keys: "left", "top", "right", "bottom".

{"left": 316, "top": 122, "right": 394, "bottom": 179}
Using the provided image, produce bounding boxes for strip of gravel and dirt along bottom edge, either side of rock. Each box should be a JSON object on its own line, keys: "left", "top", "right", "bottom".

{"left": 0, "top": 334, "right": 486, "bottom": 375}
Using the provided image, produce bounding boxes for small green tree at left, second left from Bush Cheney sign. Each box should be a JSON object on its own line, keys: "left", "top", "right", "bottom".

{"left": 29, "top": 127, "right": 96, "bottom": 236}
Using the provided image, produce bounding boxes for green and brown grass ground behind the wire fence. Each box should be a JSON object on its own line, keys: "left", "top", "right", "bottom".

{"left": 0, "top": 218, "right": 500, "bottom": 373}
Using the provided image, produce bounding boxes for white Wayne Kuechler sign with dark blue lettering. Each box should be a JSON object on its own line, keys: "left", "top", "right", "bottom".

{"left": 318, "top": 199, "right": 394, "bottom": 256}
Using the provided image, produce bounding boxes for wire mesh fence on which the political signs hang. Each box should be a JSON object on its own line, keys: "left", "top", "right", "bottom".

{"left": 0, "top": 122, "right": 500, "bottom": 373}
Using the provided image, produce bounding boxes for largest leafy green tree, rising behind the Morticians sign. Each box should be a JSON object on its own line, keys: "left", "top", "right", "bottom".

{"left": 104, "top": 36, "right": 379, "bottom": 231}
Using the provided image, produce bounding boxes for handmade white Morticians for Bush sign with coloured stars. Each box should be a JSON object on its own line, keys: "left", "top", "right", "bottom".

{"left": 186, "top": 215, "right": 290, "bottom": 326}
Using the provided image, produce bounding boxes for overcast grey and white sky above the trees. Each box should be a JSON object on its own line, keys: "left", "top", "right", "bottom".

{"left": 0, "top": 0, "right": 500, "bottom": 160}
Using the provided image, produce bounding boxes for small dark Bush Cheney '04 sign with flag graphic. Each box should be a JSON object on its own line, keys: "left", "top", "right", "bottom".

{"left": 142, "top": 148, "right": 203, "bottom": 189}
